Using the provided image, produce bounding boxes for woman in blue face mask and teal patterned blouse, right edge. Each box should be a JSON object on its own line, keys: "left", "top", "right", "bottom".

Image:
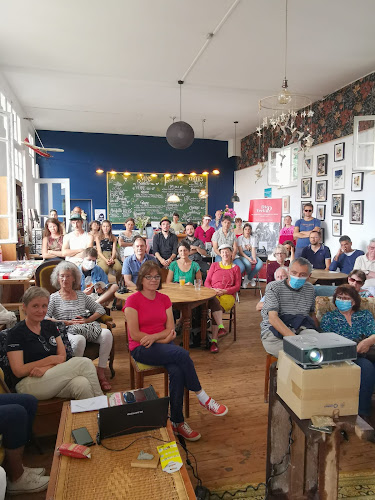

{"left": 320, "top": 285, "right": 375, "bottom": 417}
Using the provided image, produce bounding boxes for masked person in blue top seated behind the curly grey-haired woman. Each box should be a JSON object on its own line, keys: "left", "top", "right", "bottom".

{"left": 79, "top": 247, "right": 118, "bottom": 305}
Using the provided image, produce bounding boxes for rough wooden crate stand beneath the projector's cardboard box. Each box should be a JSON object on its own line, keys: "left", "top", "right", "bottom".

{"left": 266, "top": 363, "right": 374, "bottom": 500}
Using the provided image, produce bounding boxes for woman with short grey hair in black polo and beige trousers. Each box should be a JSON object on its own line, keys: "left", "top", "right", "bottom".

{"left": 7, "top": 286, "right": 103, "bottom": 400}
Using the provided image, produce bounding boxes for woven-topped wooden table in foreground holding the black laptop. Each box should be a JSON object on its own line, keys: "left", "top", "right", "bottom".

{"left": 46, "top": 402, "right": 196, "bottom": 500}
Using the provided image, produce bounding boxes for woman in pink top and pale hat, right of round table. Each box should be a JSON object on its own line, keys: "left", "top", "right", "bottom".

{"left": 204, "top": 243, "right": 241, "bottom": 353}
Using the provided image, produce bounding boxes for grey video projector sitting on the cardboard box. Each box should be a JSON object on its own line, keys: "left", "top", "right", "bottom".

{"left": 283, "top": 332, "right": 357, "bottom": 368}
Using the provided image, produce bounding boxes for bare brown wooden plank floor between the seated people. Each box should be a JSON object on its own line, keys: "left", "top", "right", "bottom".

{"left": 18, "top": 289, "right": 375, "bottom": 500}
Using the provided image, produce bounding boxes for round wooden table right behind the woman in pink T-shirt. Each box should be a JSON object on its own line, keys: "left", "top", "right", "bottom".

{"left": 115, "top": 283, "right": 216, "bottom": 350}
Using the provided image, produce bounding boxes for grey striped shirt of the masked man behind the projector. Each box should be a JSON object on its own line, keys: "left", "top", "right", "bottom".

{"left": 260, "top": 280, "right": 315, "bottom": 338}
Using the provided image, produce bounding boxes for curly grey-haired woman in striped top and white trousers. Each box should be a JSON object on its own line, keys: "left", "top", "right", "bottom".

{"left": 47, "top": 261, "right": 113, "bottom": 391}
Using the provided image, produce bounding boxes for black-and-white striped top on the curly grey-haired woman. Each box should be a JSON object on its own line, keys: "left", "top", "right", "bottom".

{"left": 47, "top": 290, "right": 105, "bottom": 321}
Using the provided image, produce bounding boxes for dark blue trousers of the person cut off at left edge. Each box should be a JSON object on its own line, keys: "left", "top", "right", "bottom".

{"left": 0, "top": 394, "right": 38, "bottom": 450}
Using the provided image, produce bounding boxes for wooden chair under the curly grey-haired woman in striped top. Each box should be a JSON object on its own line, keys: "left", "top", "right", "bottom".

{"left": 35, "top": 260, "right": 116, "bottom": 378}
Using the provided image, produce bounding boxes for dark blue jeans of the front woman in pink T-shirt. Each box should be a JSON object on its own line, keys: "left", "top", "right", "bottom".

{"left": 131, "top": 342, "right": 202, "bottom": 424}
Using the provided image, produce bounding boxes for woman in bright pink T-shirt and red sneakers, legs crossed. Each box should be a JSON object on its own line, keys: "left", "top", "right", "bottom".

{"left": 125, "top": 261, "right": 228, "bottom": 441}
